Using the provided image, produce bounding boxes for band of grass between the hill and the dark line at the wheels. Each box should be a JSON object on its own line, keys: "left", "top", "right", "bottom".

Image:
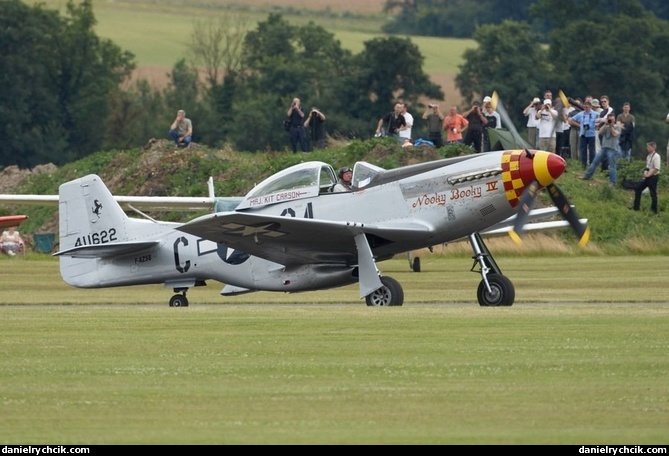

{"left": 0, "top": 255, "right": 669, "bottom": 307}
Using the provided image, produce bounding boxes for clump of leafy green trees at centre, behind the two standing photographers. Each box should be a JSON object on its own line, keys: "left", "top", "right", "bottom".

{"left": 219, "top": 14, "right": 443, "bottom": 150}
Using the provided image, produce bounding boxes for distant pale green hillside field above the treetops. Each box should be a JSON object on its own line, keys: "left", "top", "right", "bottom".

{"left": 30, "top": 0, "right": 475, "bottom": 74}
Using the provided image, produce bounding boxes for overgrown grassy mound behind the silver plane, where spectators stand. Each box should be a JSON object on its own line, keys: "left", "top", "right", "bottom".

{"left": 5, "top": 139, "right": 669, "bottom": 255}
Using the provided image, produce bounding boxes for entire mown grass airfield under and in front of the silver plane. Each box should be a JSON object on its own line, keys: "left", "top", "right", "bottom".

{"left": 0, "top": 254, "right": 669, "bottom": 445}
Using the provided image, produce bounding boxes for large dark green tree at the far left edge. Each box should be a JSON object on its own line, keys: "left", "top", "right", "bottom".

{"left": 0, "top": 0, "right": 134, "bottom": 167}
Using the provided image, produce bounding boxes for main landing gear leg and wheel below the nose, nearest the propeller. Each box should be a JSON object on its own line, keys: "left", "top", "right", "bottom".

{"left": 469, "top": 233, "right": 516, "bottom": 307}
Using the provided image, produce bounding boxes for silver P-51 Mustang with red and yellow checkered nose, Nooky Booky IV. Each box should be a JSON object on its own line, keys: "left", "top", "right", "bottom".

{"left": 19, "top": 149, "right": 589, "bottom": 307}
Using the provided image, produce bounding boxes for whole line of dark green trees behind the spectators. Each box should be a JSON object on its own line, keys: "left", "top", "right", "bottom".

{"left": 0, "top": 0, "right": 669, "bottom": 168}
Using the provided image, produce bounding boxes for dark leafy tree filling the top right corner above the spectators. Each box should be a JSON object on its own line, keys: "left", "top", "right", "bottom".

{"left": 538, "top": 0, "right": 669, "bottom": 156}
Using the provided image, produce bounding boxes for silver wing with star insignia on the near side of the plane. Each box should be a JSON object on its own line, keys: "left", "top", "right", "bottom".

{"left": 177, "top": 212, "right": 430, "bottom": 266}
